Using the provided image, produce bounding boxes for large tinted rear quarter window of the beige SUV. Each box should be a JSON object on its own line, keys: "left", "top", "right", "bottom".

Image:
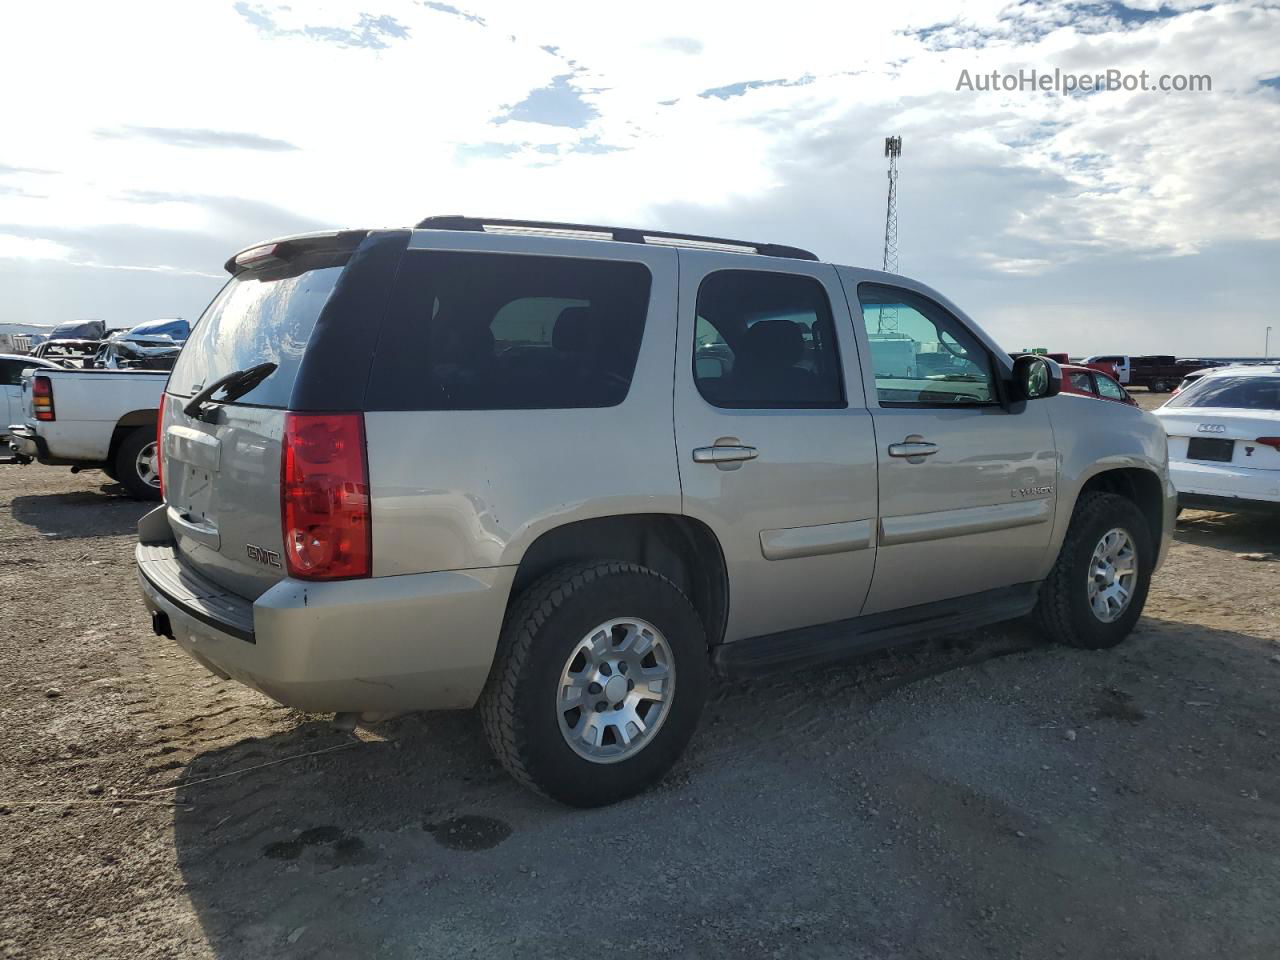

{"left": 367, "top": 251, "right": 652, "bottom": 410}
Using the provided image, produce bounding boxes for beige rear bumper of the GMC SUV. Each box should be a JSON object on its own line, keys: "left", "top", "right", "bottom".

{"left": 136, "top": 544, "right": 516, "bottom": 713}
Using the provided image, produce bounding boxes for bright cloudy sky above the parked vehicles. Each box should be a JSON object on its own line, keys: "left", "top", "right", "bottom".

{"left": 0, "top": 0, "right": 1280, "bottom": 356}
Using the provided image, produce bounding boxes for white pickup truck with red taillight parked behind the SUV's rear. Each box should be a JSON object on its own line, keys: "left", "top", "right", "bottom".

{"left": 8, "top": 369, "right": 169, "bottom": 500}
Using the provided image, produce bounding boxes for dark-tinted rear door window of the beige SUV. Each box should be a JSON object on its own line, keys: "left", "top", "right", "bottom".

{"left": 694, "top": 270, "right": 845, "bottom": 410}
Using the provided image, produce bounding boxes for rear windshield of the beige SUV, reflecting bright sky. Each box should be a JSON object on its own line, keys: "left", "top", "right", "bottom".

{"left": 168, "top": 255, "right": 343, "bottom": 407}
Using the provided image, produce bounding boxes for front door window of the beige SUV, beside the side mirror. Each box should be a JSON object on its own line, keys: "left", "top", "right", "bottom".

{"left": 858, "top": 283, "right": 997, "bottom": 407}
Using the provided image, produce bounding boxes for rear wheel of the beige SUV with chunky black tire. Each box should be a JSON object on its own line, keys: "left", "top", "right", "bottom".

{"left": 480, "top": 561, "right": 710, "bottom": 806}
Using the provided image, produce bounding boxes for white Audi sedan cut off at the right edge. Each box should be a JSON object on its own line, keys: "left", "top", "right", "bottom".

{"left": 1153, "top": 365, "right": 1280, "bottom": 512}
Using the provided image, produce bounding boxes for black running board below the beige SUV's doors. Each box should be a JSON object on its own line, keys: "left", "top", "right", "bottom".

{"left": 712, "top": 581, "right": 1039, "bottom": 680}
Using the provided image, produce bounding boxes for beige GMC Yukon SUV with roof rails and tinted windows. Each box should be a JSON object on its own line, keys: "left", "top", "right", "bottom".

{"left": 137, "top": 216, "right": 1175, "bottom": 806}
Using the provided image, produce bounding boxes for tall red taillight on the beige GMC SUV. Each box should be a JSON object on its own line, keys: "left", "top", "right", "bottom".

{"left": 280, "top": 413, "right": 372, "bottom": 580}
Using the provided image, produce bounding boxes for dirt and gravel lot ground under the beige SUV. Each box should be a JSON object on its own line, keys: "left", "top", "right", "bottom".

{"left": 0, "top": 394, "right": 1280, "bottom": 960}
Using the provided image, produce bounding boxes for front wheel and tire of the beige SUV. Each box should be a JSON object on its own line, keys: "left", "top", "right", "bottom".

{"left": 1033, "top": 493, "right": 1156, "bottom": 650}
